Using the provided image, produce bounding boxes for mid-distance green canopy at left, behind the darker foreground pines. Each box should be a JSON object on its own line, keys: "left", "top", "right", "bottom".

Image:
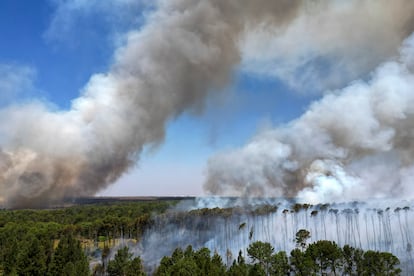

{"left": 0, "top": 201, "right": 175, "bottom": 239}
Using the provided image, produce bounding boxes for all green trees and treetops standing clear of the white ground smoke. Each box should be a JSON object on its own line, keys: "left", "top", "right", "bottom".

{"left": 0, "top": 200, "right": 401, "bottom": 275}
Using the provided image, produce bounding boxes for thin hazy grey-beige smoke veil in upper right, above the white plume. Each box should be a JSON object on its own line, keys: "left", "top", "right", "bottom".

{"left": 242, "top": 0, "right": 413, "bottom": 93}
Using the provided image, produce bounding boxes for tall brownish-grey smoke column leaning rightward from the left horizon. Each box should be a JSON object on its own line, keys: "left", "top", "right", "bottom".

{"left": 0, "top": 0, "right": 301, "bottom": 206}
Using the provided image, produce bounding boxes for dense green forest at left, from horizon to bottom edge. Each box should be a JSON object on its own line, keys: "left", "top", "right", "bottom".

{"left": 0, "top": 201, "right": 173, "bottom": 275}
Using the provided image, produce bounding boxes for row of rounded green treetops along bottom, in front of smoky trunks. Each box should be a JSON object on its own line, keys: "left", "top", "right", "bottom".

{"left": 154, "top": 240, "right": 401, "bottom": 276}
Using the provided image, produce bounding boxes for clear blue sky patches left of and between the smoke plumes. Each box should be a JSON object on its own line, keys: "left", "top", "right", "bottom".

{"left": 0, "top": 0, "right": 314, "bottom": 196}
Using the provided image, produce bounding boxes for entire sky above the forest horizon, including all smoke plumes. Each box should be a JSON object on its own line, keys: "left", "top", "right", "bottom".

{"left": 0, "top": 0, "right": 414, "bottom": 207}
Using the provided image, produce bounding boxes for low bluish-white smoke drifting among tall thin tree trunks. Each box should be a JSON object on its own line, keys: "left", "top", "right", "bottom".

{"left": 137, "top": 198, "right": 414, "bottom": 275}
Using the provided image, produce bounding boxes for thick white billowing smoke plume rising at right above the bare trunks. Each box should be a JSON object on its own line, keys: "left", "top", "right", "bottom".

{"left": 205, "top": 35, "right": 414, "bottom": 203}
